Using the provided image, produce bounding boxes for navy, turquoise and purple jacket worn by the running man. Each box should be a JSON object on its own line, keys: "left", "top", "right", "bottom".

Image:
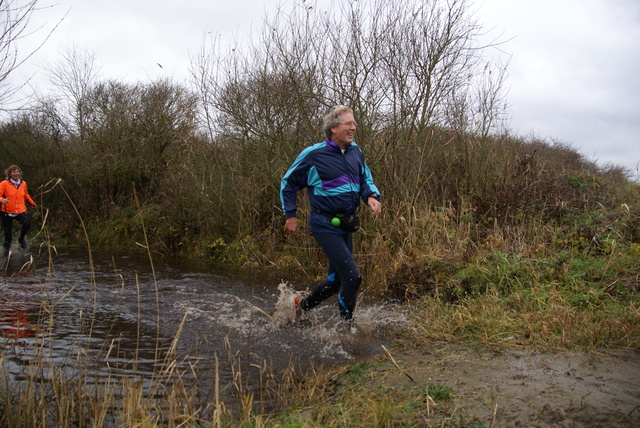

{"left": 280, "top": 139, "right": 380, "bottom": 233}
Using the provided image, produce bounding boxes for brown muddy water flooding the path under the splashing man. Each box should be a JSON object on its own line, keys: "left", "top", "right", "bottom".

{"left": 0, "top": 249, "right": 405, "bottom": 400}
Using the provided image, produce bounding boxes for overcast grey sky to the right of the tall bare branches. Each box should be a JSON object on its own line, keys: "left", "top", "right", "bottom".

{"left": 478, "top": 0, "right": 640, "bottom": 176}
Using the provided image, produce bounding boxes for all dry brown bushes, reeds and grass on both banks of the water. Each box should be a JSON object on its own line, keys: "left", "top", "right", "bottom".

{"left": 0, "top": 0, "right": 640, "bottom": 426}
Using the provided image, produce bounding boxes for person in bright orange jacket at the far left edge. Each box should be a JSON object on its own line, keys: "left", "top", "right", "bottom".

{"left": 0, "top": 165, "right": 36, "bottom": 251}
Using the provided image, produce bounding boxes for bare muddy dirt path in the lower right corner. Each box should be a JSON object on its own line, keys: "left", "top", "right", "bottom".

{"left": 378, "top": 345, "right": 640, "bottom": 427}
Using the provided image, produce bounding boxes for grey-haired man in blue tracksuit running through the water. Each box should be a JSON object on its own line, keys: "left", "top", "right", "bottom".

{"left": 280, "top": 105, "right": 382, "bottom": 321}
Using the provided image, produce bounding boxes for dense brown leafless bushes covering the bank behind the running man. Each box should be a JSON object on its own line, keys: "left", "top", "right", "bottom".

{"left": 0, "top": 0, "right": 639, "bottom": 294}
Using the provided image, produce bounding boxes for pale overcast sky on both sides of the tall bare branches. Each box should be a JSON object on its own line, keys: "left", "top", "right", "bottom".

{"left": 14, "top": 0, "right": 640, "bottom": 174}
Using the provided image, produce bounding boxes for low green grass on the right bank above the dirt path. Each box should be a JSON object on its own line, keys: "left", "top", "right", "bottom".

{"left": 404, "top": 242, "right": 640, "bottom": 350}
